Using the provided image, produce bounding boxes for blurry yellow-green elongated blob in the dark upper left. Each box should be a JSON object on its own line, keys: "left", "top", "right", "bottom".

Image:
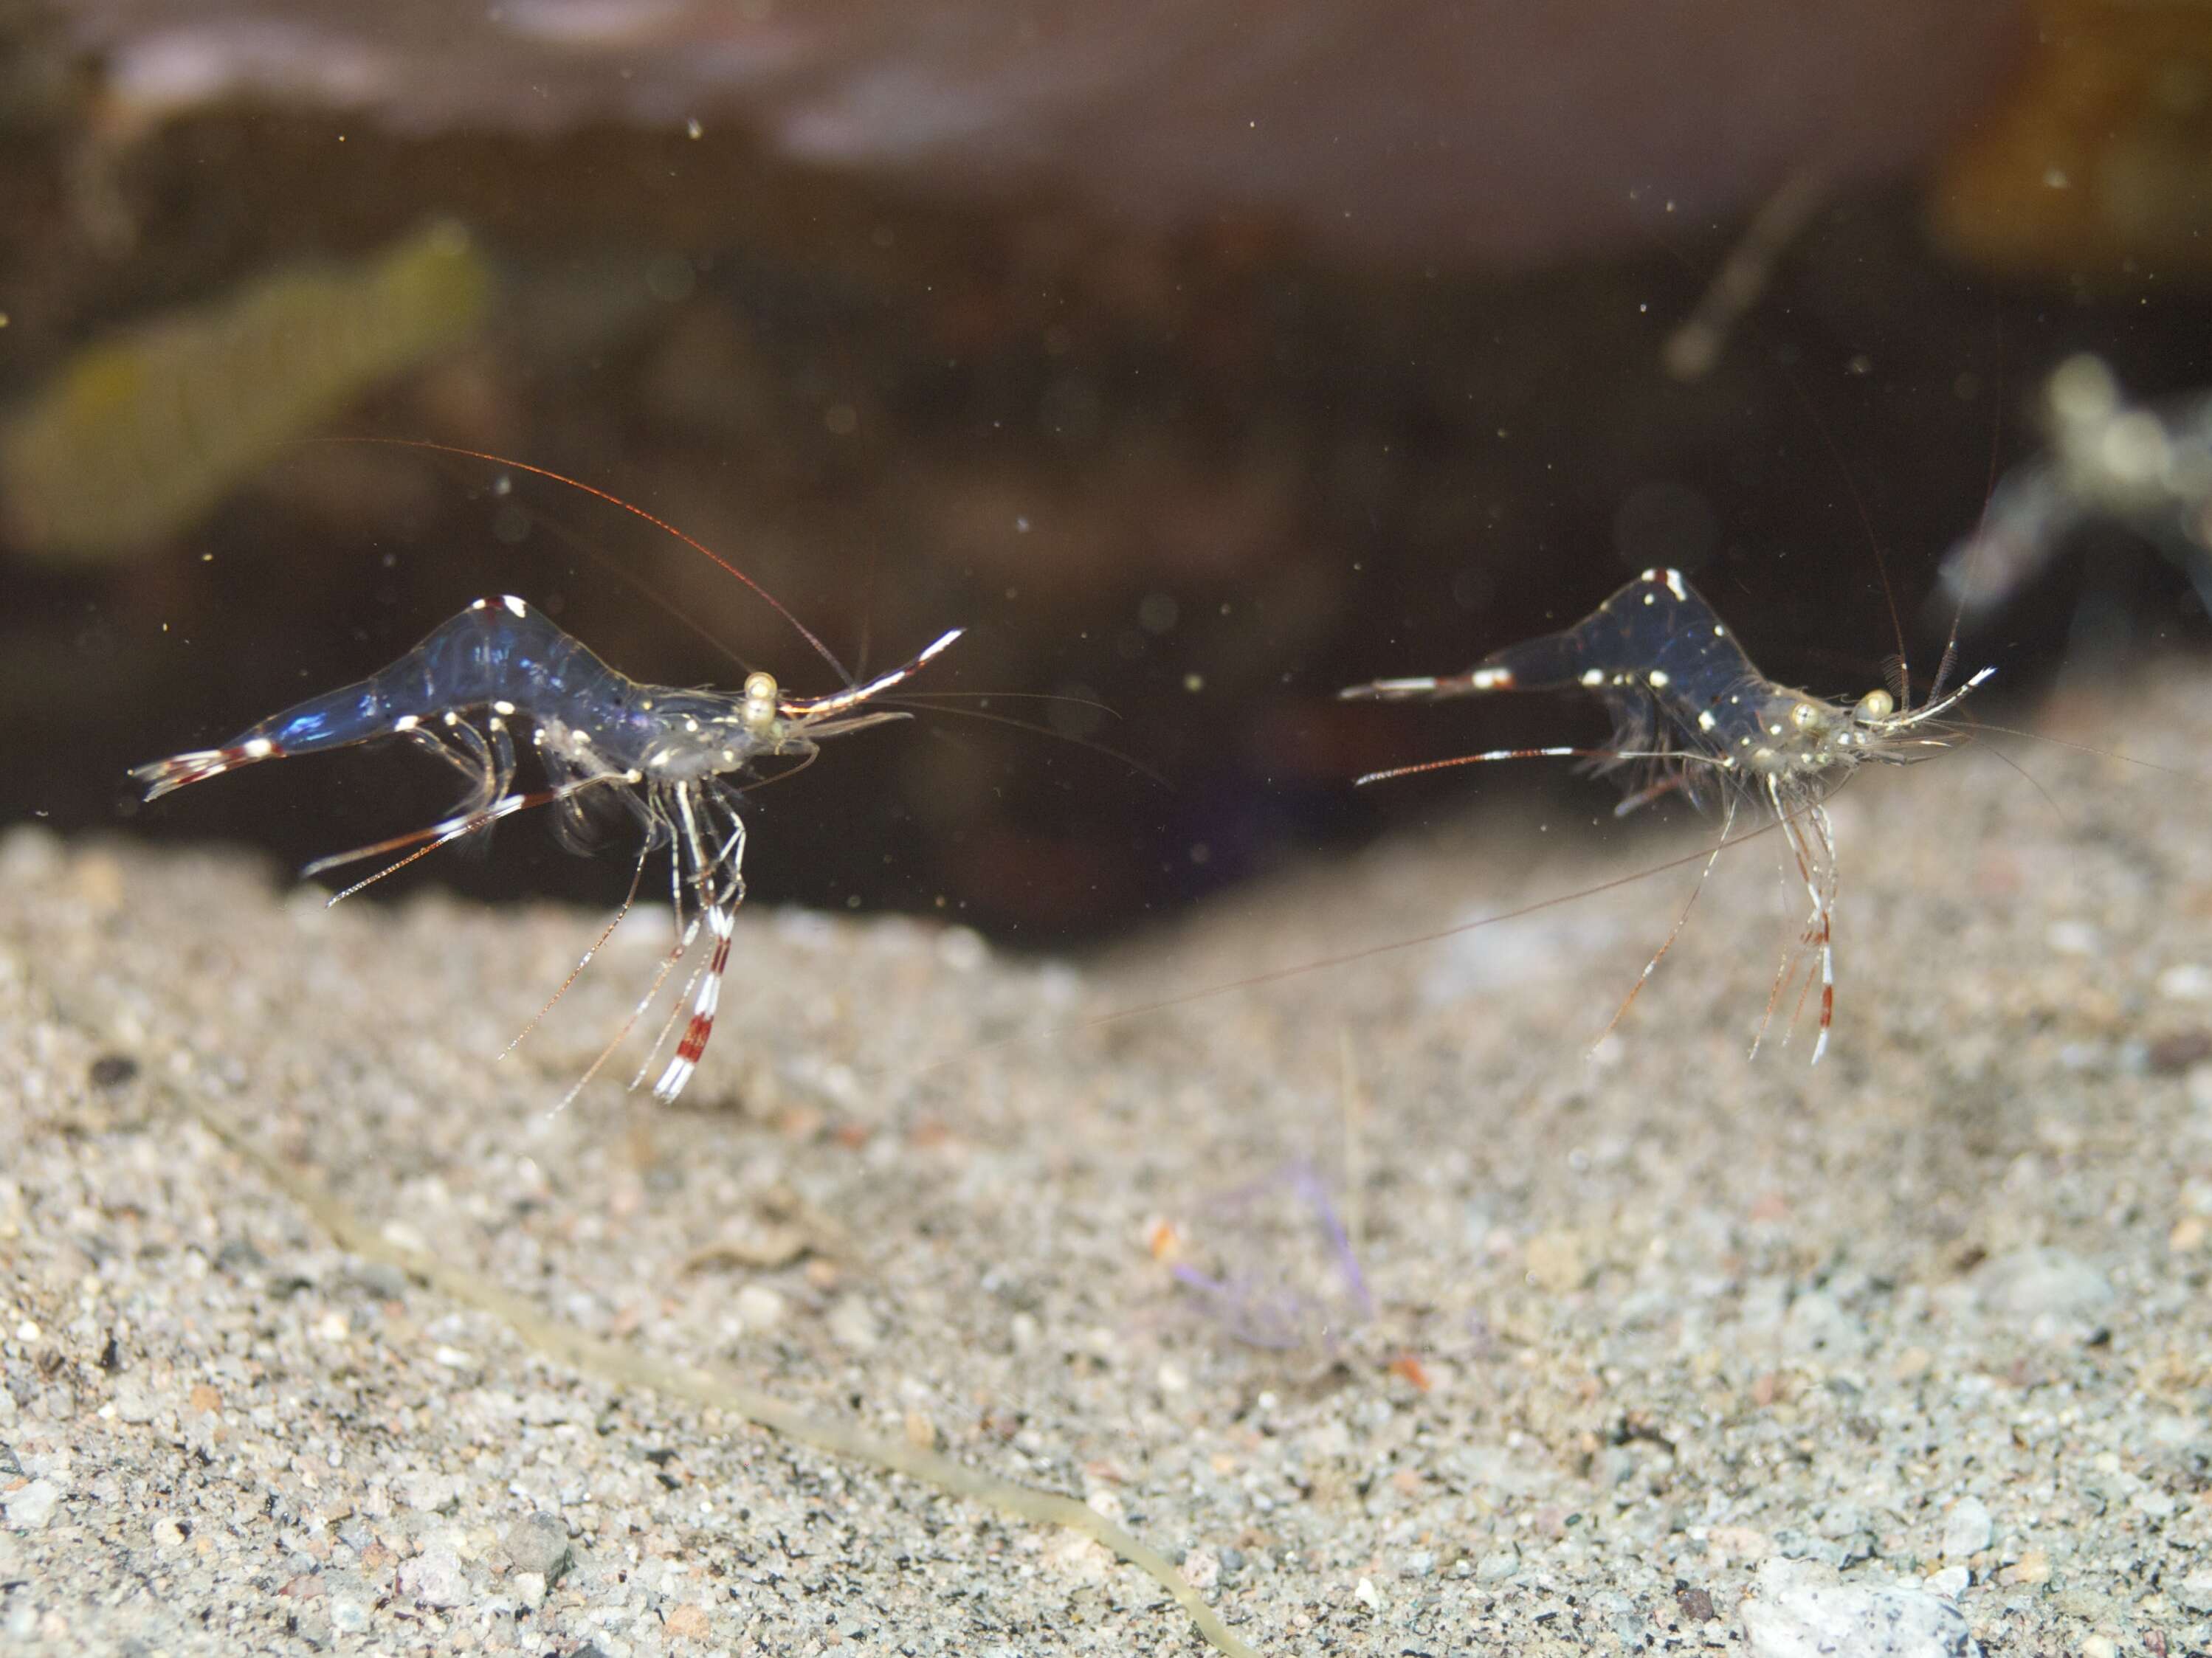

{"left": 0, "top": 221, "right": 491, "bottom": 562}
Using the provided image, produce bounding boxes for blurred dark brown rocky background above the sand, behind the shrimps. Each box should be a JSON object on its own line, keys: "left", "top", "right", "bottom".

{"left": 0, "top": 0, "right": 2212, "bottom": 946}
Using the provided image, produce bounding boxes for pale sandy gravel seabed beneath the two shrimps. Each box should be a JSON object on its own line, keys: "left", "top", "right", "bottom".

{"left": 0, "top": 670, "right": 2212, "bottom": 1658}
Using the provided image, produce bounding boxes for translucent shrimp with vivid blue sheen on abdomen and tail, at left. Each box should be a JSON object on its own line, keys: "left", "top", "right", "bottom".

{"left": 131, "top": 597, "right": 960, "bottom": 1101}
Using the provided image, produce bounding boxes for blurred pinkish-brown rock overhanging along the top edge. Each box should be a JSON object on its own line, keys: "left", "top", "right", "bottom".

{"left": 71, "top": 0, "right": 2024, "bottom": 263}
